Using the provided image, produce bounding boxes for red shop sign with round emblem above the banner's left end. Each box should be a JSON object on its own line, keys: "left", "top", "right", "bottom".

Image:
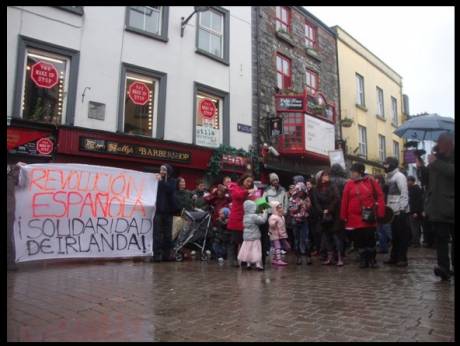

{"left": 6, "top": 128, "right": 55, "bottom": 157}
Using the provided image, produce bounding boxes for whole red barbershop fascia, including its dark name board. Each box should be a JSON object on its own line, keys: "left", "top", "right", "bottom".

{"left": 54, "top": 126, "right": 212, "bottom": 189}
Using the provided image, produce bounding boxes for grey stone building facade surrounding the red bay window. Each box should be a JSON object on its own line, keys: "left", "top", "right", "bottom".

{"left": 252, "top": 6, "right": 340, "bottom": 184}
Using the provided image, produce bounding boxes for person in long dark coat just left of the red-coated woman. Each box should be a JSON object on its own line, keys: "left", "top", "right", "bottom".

{"left": 313, "top": 169, "right": 343, "bottom": 266}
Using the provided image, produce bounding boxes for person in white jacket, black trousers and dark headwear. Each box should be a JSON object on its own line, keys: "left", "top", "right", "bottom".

{"left": 383, "top": 156, "right": 411, "bottom": 267}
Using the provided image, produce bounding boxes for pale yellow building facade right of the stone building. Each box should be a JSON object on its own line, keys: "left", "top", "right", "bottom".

{"left": 333, "top": 26, "right": 405, "bottom": 174}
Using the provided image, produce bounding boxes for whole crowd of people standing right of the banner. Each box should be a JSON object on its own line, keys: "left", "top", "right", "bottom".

{"left": 153, "top": 134, "right": 454, "bottom": 280}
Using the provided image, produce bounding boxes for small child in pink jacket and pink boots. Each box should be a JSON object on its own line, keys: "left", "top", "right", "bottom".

{"left": 268, "top": 201, "right": 290, "bottom": 266}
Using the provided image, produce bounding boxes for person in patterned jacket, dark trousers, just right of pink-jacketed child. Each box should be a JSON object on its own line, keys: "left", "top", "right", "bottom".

{"left": 289, "top": 183, "right": 312, "bottom": 265}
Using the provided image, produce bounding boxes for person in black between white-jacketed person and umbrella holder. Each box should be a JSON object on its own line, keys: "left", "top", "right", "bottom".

{"left": 407, "top": 176, "right": 423, "bottom": 247}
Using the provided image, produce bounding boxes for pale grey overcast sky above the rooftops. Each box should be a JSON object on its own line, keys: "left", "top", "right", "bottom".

{"left": 305, "top": 6, "right": 455, "bottom": 117}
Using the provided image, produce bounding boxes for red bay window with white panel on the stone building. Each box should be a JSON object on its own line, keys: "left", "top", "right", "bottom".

{"left": 264, "top": 91, "right": 336, "bottom": 185}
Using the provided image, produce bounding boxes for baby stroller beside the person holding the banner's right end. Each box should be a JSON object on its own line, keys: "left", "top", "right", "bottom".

{"left": 174, "top": 207, "right": 213, "bottom": 262}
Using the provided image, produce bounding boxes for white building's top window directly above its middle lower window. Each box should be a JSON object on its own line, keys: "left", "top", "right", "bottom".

{"left": 127, "top": 6, "right": 163, "bottom": 36}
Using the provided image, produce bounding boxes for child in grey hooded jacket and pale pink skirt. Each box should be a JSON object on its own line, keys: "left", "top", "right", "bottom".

{"left": 238, "top": 200, "right": 268, "bottom": 270}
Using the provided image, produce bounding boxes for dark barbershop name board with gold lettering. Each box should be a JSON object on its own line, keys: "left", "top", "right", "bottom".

{"left": 80, "top": 137, "right": 192, "bottom": 162}
